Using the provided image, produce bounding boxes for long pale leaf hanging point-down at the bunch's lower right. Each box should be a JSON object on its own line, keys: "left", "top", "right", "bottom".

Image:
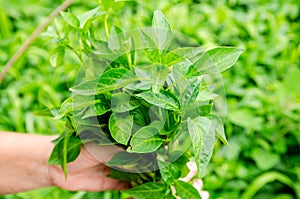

{"left": 188, "top": 117, "right": 215, "bottom": 177}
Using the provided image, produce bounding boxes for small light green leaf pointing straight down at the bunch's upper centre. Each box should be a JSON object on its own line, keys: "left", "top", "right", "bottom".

{"left": 150, "top": 64, "right": 169, "bottom": 94}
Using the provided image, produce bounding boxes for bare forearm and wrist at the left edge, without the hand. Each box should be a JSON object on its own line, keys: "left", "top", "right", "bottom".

{"left": 0, "top": 132, "right": 55, "bottom": 194}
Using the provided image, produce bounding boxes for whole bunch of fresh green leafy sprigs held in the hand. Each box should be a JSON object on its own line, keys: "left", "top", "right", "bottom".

{"left": 49, "top": 4, "right": 242, "bottom": 199}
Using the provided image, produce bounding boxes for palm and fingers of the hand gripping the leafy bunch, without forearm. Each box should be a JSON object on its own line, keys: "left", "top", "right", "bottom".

{"left": 49, "top": 143, "right": 129, "bottom": 191}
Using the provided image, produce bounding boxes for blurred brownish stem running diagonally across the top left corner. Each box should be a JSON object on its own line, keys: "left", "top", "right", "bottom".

{"left": 0, "top": 0, "right": 73, "bottom": 84}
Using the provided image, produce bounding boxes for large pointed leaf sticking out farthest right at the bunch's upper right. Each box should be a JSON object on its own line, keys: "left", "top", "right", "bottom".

{"left": 189, "top": 47, "right": 243, "bottom": 75}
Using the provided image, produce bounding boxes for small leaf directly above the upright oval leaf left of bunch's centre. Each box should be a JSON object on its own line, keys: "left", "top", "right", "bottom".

{"left": 111, "top": 93, "right": 141, "bottom": 113}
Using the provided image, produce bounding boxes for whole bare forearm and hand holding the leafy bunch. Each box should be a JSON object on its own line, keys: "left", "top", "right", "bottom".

{"left": 0, "top": 132, "right": 129, "bottom": 195}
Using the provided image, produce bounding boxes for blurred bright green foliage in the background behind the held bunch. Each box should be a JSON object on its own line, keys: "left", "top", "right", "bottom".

{"left": 0, "top": 0, "right": 300, "bottom": 199}
